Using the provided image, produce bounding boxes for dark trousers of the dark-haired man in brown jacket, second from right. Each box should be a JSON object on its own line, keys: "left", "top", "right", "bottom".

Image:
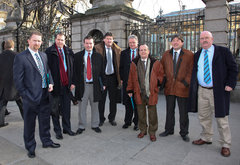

{"left": 165, "top": 95, "right": 189, "bottom": 136}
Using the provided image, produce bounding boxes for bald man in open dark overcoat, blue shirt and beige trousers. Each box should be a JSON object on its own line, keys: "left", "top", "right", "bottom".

{"left": 189, "top": 31, "right": 238, "bottom": 157}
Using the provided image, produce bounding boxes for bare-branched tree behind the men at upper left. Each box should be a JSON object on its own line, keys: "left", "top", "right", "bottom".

{"left": 0, "top": 0, "right": 90, "bottom": 50}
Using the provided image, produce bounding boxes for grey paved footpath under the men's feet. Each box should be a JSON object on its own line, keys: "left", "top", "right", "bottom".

{"left": 0, "top": 95, "right": 240, "bottom": 165}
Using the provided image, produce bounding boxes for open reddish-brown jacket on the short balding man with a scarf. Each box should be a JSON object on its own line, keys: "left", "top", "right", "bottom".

{"left": 127, "top": 56, "right": 163, "bottom": 105}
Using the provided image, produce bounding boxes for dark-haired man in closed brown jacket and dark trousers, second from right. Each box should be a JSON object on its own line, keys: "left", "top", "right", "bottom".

{"left": 160, "top": 35, "right": 193, "bottom": 142}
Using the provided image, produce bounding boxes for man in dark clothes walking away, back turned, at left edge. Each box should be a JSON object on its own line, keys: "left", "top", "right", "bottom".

{"left": 0, "top": 40, "right": 23, "bottom": 127}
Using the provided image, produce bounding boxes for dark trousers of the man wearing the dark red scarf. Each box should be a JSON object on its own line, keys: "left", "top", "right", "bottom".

{"left": 51, "top": 86, "right": 71, "bottom": 135}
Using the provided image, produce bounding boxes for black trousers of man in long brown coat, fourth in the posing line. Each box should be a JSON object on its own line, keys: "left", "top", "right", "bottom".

{"left": 98, "top": 74, "right": 118, "bottom": 122}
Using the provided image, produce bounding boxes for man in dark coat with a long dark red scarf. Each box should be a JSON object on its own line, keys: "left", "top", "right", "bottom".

{"left": 46, "top": 33, "right": 75, "bottom": 139}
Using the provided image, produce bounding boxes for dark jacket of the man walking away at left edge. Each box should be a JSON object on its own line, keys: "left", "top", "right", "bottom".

{"left": 0, "top": 50, "right": 19, "bottom": 101}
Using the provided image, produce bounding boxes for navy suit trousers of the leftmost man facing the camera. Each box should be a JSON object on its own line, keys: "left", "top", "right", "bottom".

{"left": 23, "top": 88, "right": 52, "bottom": 152}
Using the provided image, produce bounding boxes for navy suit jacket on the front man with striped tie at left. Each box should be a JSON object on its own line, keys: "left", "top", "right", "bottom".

{"left": 13, "top": 49, "right": 53, "bottom": 104}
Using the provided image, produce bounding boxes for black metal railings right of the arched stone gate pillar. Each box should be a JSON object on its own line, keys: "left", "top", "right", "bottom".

{"left": 126, "top": 3, "right": 240, "bottom": 58}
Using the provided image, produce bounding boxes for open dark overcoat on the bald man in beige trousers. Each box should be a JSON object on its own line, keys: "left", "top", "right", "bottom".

{"left": 188, "top": 45, "right": 238, "bottom": 117}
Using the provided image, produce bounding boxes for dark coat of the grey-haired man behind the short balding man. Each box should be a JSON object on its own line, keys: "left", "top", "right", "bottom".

{"left": 119, "top": 48, "right": 139, "bottom": 104}
